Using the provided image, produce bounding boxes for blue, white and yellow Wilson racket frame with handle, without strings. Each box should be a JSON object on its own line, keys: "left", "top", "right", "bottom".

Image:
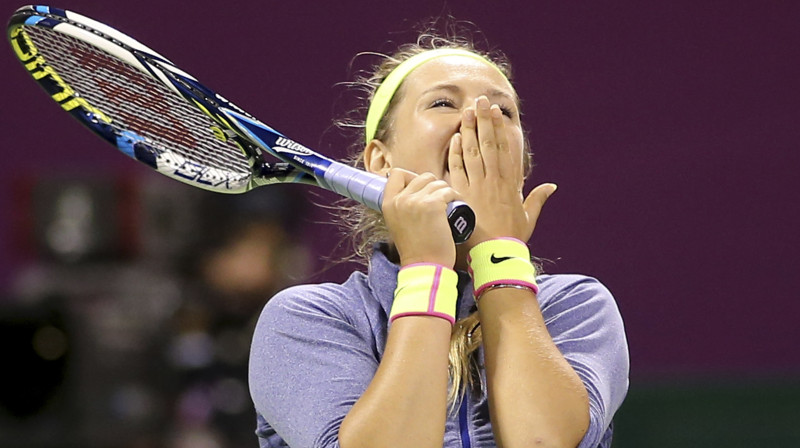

{"left": 8, "top": 6, "right": 475, "bottom": 243}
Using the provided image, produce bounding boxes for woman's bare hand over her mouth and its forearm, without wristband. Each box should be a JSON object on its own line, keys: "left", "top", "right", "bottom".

{"left": 449, "top": 96, "right": 589, "bottom": 447}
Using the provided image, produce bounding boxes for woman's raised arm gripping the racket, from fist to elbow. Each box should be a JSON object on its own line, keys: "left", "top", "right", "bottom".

{"left": 339, "top": 169, "right": 466, "bottom": 448}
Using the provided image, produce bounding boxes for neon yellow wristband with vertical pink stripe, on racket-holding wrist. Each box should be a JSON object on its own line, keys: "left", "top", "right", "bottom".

{"left": 389, "top": 263, "right": 458, "bottom": 324}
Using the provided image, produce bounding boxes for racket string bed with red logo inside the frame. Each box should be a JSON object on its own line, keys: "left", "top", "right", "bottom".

{"left": 26, "top": 27, "right": 250, "bottom": 174}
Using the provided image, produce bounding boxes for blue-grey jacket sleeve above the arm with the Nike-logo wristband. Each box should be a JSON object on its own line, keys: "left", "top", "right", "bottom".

{"left": 539, "top": 275, "right": 630, "bottom": 448}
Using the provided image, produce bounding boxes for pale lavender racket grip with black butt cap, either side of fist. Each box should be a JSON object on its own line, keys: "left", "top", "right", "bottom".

{"left": 320, "top": 162, "right": 475, "bottom": 244}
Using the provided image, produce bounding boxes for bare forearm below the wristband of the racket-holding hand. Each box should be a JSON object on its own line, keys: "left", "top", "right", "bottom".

{"left": 339, "top": 316, "right": 451, "bottom": 448}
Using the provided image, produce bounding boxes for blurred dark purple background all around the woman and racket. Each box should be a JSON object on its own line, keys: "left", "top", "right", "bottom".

{"left": 0, "top": 0, "right": 800, "bottom": 448}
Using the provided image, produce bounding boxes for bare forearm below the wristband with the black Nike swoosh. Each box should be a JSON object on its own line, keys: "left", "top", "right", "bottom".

{"left": 478, "top": 288, "right": 589, "bottom": 448}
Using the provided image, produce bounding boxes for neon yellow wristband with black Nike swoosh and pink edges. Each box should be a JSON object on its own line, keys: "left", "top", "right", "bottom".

{"left": 467, "top": 238, "right": 539, "bottom": 300}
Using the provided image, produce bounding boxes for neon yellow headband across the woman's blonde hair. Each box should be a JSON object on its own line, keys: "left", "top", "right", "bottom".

{"left": 366, "top": 48, "right": 506, "bottom": 143}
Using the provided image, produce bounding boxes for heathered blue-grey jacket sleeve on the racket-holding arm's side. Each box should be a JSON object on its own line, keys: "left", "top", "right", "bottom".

{"left": 250, "top": 285, "right": 379, "bottom": 447}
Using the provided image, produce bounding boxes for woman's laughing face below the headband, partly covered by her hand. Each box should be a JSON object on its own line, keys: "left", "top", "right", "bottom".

{"left": 368, "top": 56, "right": 524, "bottom": 183}
